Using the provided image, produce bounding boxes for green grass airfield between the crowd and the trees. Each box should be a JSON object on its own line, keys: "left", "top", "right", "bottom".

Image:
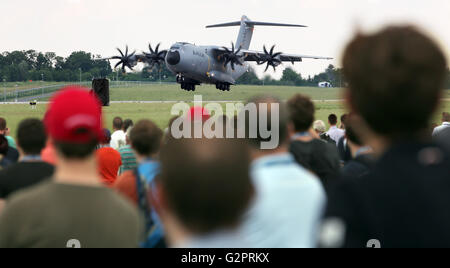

{"left": 0, "top": 85, "right": 450, "bottom": 136}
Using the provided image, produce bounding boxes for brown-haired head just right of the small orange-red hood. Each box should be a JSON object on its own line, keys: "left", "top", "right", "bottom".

{"left": 130, "top": 120, "right": 163, "bottom": 157}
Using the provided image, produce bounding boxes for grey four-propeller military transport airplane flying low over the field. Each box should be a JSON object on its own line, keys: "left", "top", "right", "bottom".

{"left": 107, "top": 15, "right": 333, "bottom": 91}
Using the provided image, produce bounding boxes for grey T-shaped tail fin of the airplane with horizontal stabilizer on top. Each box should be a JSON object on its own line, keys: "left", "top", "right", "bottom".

{"left": 206, "top": 16, "right": 307, "bottom": 49}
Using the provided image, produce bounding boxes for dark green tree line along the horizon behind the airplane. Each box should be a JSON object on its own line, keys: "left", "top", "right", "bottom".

{"left": 0, "top": 50, "right": 450, "bottom": 89}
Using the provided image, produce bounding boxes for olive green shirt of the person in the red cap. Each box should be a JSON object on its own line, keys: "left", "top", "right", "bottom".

{"left": 0, "top": 181, "right": 142, "bottom": 248}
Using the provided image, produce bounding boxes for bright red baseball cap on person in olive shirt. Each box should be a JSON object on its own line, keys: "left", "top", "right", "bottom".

{"left": 44, "top": 86, "right": 104, "bottom": 144}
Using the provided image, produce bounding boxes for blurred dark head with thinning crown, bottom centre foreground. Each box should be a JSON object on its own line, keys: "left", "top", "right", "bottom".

{"left": 158, "top": 138, "right": 253, "bottom": 243}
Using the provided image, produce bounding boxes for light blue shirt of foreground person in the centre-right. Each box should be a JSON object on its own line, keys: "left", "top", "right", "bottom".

{"left": 240, "top": 153, "right": 326, "bottom": 248}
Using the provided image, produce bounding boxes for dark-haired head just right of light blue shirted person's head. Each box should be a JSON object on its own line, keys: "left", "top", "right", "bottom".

{"left": 287, "top": 94, "right": 316, "bottom": 132}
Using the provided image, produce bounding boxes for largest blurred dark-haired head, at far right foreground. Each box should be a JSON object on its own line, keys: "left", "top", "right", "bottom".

{"left": 343, "top": 26, "right": 447, "bottom": 142}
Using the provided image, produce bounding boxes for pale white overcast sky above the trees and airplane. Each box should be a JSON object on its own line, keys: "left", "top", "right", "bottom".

{"left": 0, "top": 0, "right": 450, "bottom": 78}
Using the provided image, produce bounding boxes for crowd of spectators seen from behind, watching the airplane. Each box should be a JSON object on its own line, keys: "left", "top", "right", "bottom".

{"left": 0, "top": 24, "right": 450, "bottom": 248}
